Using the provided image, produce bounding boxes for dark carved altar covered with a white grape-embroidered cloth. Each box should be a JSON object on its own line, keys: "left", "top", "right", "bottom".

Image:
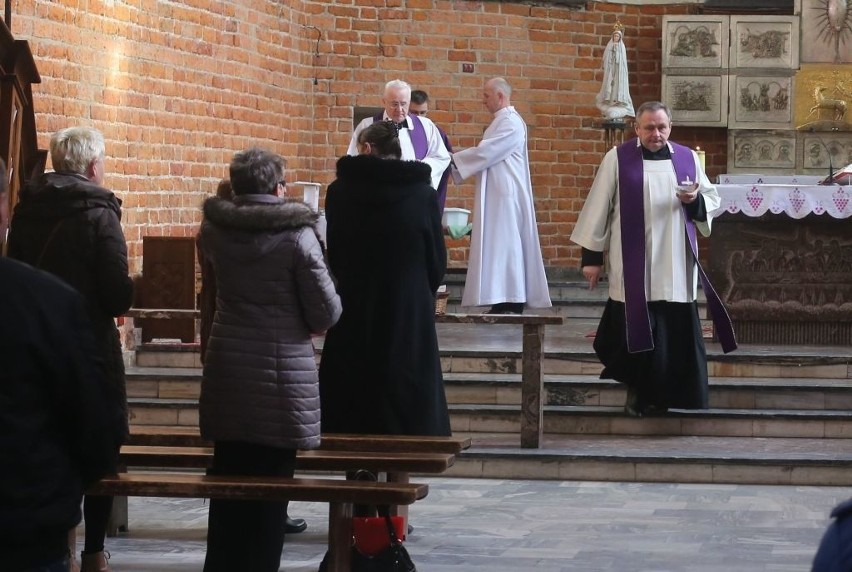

{"left": 708, "top": 184, "right": 852, "bottom": 345}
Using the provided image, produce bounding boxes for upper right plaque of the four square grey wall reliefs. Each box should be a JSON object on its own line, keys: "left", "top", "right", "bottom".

{"left": 730, "top": 16, "right": 799, "bottom": 70}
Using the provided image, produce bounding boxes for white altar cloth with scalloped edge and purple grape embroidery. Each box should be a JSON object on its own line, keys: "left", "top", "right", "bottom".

{"left": 712, "top": 185, "right": 852, "bottom": 219}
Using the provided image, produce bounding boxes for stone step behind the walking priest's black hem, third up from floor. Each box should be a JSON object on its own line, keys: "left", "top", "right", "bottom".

{"left": 126, "top": 367, "right": 852, "bottom": 410}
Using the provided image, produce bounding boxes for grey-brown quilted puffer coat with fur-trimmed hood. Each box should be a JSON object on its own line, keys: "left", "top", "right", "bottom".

{"left": 199, "top": 195, "right": 341, "bottom": 449}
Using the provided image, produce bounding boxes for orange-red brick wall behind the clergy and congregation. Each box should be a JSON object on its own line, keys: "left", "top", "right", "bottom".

{"left": 12, "top": 0, "right": 726, "bottom": 271}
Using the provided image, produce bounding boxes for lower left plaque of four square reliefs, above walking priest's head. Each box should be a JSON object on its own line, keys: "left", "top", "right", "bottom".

{"left": 663, "top": 74, "right": 728, "bottom": 127}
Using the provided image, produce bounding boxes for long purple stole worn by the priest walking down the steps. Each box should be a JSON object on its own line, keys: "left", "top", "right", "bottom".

{"left": 616, "top": 138, "right": 737, "bottom": 353}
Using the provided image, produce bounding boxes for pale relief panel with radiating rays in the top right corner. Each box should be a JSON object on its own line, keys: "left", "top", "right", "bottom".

{"left": 800, "top": 0, "right": 852, "bottom": 64}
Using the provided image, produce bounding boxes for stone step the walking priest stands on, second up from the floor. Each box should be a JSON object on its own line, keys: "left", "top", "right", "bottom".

{"left": 128, "top": 398, "right": 852, "bottom": 439}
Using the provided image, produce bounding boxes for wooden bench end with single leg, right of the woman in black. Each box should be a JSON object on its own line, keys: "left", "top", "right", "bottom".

{"left": 435, "top": 314, "right": 564, "bottom": 449}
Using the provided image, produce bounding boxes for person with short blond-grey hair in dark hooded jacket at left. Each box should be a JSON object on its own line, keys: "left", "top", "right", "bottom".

{"left": 9, "top": 127, "right": 133, "bottom": 572}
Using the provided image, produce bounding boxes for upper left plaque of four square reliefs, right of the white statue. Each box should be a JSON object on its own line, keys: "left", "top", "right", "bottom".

{"left": 662, "top": 16, "right": 730, "bottom": 71}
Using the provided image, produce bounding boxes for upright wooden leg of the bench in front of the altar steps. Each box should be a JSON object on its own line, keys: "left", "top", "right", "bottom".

{"left": 521, "top": 324, "right": 544, "bottom": 449}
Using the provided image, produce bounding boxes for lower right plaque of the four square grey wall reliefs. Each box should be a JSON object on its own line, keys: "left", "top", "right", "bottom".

{"left": 728, "top": 75, "right": 793, "bottom": 129}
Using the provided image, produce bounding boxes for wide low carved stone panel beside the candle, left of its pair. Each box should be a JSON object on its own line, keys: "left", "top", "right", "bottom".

{"left": 728, "top": 129, "right": 797, "bottom": 174}
